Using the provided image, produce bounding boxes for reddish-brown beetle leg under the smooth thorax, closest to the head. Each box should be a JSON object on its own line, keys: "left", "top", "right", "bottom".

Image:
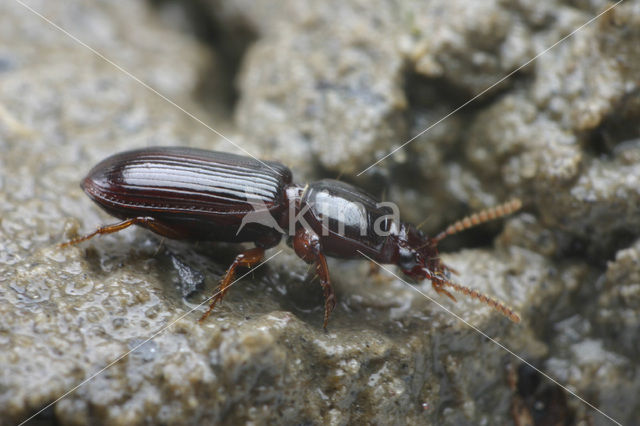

{"left": 293, "top": 228, "right": 336, "bottom": 331}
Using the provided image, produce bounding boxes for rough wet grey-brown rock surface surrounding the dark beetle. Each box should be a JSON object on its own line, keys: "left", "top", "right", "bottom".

{"left": 0, "top": 0, "right": 640, "bottom": 425}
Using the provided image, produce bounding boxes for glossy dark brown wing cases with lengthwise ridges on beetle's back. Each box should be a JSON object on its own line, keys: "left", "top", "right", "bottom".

{"left": 82, "top": 147, "right": 291, "bottom": 219}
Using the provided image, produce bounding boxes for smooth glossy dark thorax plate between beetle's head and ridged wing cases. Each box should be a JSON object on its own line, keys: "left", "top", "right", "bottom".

{"left": 301, "top": 179, "right": 397, "bottom": 258}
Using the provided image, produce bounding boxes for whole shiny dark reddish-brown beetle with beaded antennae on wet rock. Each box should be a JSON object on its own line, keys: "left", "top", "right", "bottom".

{"left": 61, "top": 147, "right": 521, "bottom": 330}
